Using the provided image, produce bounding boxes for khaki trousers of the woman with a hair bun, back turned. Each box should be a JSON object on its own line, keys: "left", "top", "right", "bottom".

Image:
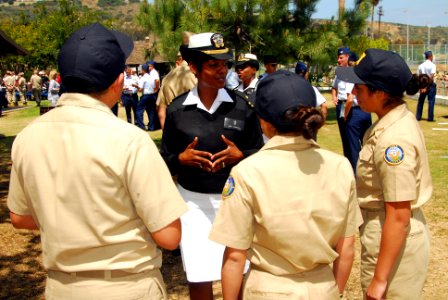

{"left": 243, "top": 265, "right": 339, "bottom": 300}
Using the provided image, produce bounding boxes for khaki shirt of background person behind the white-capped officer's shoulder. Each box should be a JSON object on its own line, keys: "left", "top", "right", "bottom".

{"left": 156, "top": 61, "right": 197, "bottom": 107}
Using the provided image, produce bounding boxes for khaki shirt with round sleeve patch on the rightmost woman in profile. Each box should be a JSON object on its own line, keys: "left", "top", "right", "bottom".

{"left": 356, "top": 104, "right": 432, "bottom": 209}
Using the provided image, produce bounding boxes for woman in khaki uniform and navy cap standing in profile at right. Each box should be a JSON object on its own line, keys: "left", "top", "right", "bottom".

{"left": 336, "top": 49, "right": 432, "bottom": 299}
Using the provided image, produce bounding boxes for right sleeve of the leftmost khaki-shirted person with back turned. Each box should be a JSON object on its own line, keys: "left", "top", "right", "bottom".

{"left": 125, "top": 136, "right": 188, "bottom": 232}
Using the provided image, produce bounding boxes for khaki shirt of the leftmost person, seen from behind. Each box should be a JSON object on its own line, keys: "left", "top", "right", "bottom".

{"left": 8, "top": 93, "right": 187, "bottom": 273}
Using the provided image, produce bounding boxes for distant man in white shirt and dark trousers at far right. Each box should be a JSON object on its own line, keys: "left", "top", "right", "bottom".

{"left": 416, "top": 51, "right": 437, "bottom": 122}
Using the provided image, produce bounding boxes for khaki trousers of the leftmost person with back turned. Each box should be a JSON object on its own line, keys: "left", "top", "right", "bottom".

{"left": 45, "top": 269, "right": 167, "bottom": 300}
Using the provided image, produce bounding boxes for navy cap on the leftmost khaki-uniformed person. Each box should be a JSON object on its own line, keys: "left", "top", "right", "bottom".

{"left": 58, "top": 23, "right": 134, "bottom": 92}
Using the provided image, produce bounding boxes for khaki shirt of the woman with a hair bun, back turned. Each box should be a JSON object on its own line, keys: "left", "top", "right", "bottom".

{"left": 210, "top": 136, "right": 362, "bottom": 275}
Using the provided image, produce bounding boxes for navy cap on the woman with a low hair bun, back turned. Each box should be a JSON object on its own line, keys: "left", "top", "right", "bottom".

{"left": 255, "top": 70, "right": 316, "bottom": 131}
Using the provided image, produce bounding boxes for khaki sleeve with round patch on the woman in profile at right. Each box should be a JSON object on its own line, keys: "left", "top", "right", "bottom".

{"left": 374, "top": 134, "right": 420, "bottom": 202}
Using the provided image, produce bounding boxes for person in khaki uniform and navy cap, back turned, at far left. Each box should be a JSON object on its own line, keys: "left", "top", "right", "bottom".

{"left": 8, "top": 23, "right": 187, "bottom": 300}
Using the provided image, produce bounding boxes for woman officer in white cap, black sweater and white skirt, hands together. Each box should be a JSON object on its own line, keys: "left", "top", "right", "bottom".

{"left": 161, "top": 33, "right": 262, "bottom": 299}
